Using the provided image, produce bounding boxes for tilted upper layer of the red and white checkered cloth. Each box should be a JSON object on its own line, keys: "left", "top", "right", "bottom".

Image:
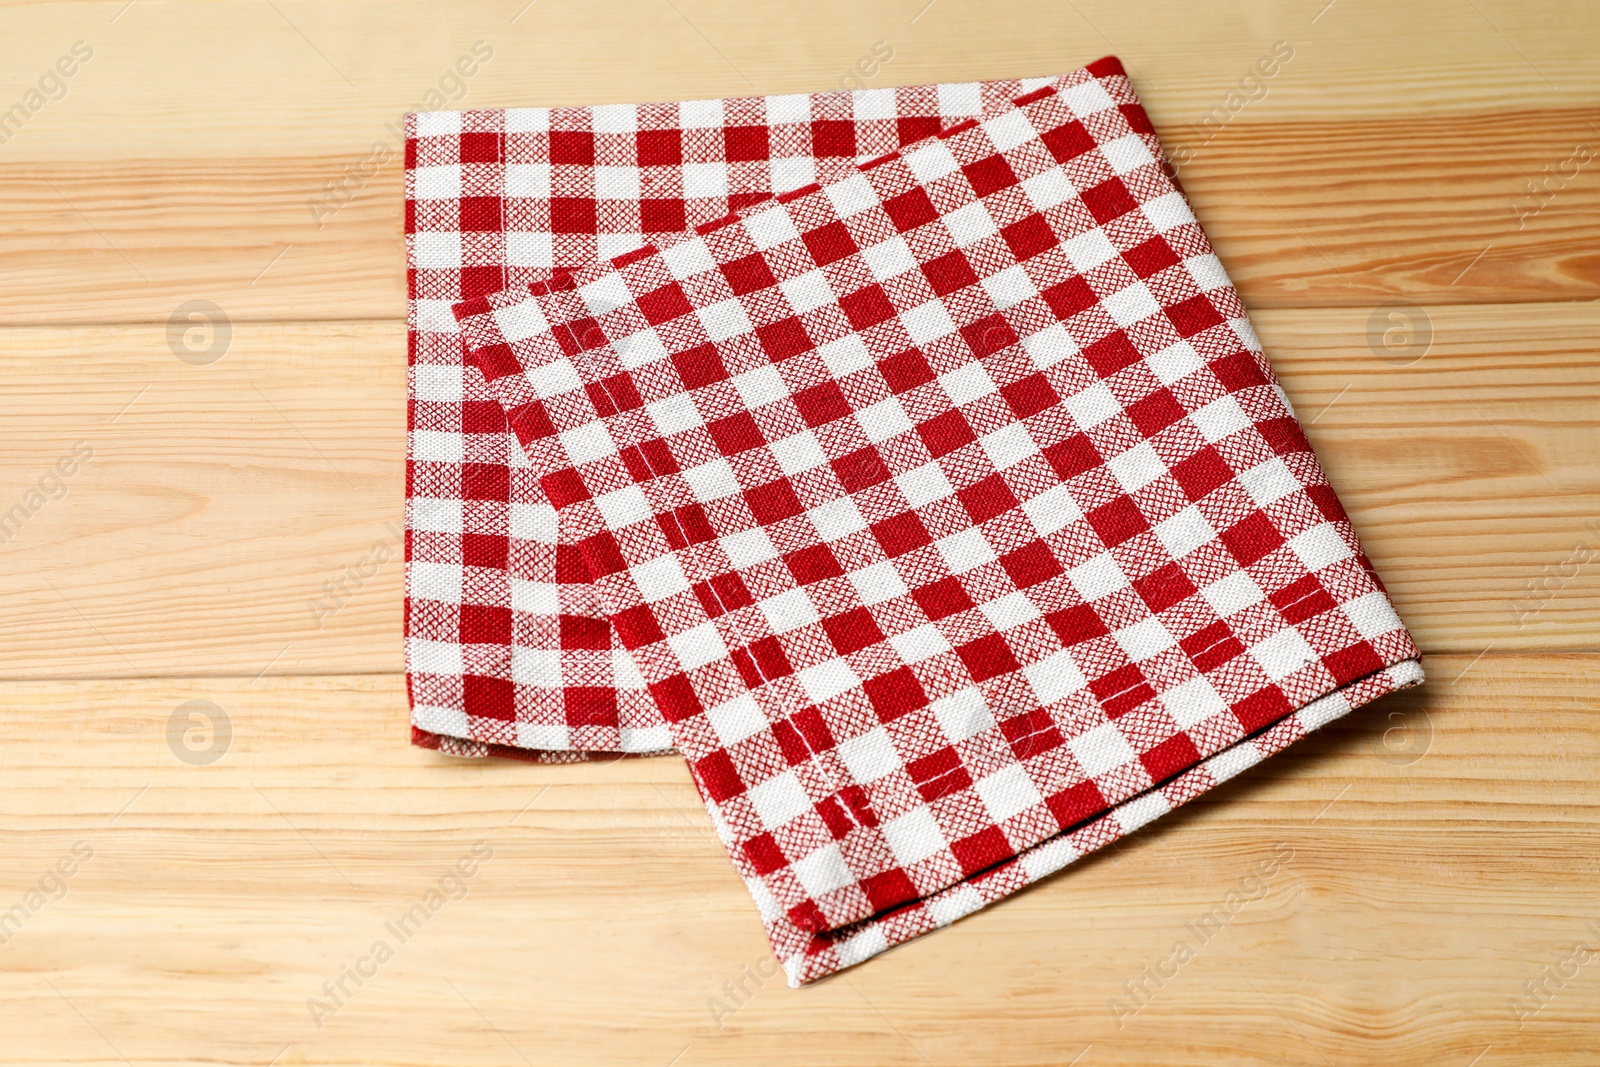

{"left": 438, "top": 75, "right": 1421, "bottom": 984}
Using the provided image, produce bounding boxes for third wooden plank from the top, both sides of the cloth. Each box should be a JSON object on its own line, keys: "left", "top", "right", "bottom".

{"left": 0, "top": 304, "right": 1600, "bottom": 678}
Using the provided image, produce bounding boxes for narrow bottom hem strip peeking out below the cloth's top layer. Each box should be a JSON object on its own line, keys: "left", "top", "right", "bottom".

{"left": 768, "top": 657, "right": 1422, "bottom": 989}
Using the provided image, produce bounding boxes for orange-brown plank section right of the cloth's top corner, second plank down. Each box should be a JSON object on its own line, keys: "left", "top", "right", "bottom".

{"left": 1184, "top": 107, "right": 1600, "bottom": 309}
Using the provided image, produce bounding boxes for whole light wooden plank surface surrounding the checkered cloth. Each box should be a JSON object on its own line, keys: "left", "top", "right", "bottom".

{"left": 0, "top": 0, "right": 1600, "bottom": 1067}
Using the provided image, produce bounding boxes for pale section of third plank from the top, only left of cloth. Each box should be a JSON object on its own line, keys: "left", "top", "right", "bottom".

{"left": 0, "top": 323, "right": 405, "bottom": 677}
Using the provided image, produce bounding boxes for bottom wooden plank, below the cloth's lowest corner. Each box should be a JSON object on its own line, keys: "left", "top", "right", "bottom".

{"left": 0, "top": 653, "right": 1600, "bottom": 1067}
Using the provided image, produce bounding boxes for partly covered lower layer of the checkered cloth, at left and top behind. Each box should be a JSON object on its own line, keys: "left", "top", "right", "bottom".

{"left": 406, "top": 59, "right": 1100, "bottom": 760}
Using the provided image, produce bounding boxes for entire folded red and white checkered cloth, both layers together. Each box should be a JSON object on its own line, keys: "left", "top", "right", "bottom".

{"left": 406, "top": 51, "right": 1422, "bottom": 985}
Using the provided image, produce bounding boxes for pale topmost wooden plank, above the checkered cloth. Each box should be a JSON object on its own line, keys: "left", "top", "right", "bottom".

{"left": 0, "top": 0, "right": 1600, "bottom": 160}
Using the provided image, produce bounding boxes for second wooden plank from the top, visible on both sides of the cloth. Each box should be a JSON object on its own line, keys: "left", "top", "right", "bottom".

{"left": 12, "top": 109, "right": 1600, "bottom": 323}
